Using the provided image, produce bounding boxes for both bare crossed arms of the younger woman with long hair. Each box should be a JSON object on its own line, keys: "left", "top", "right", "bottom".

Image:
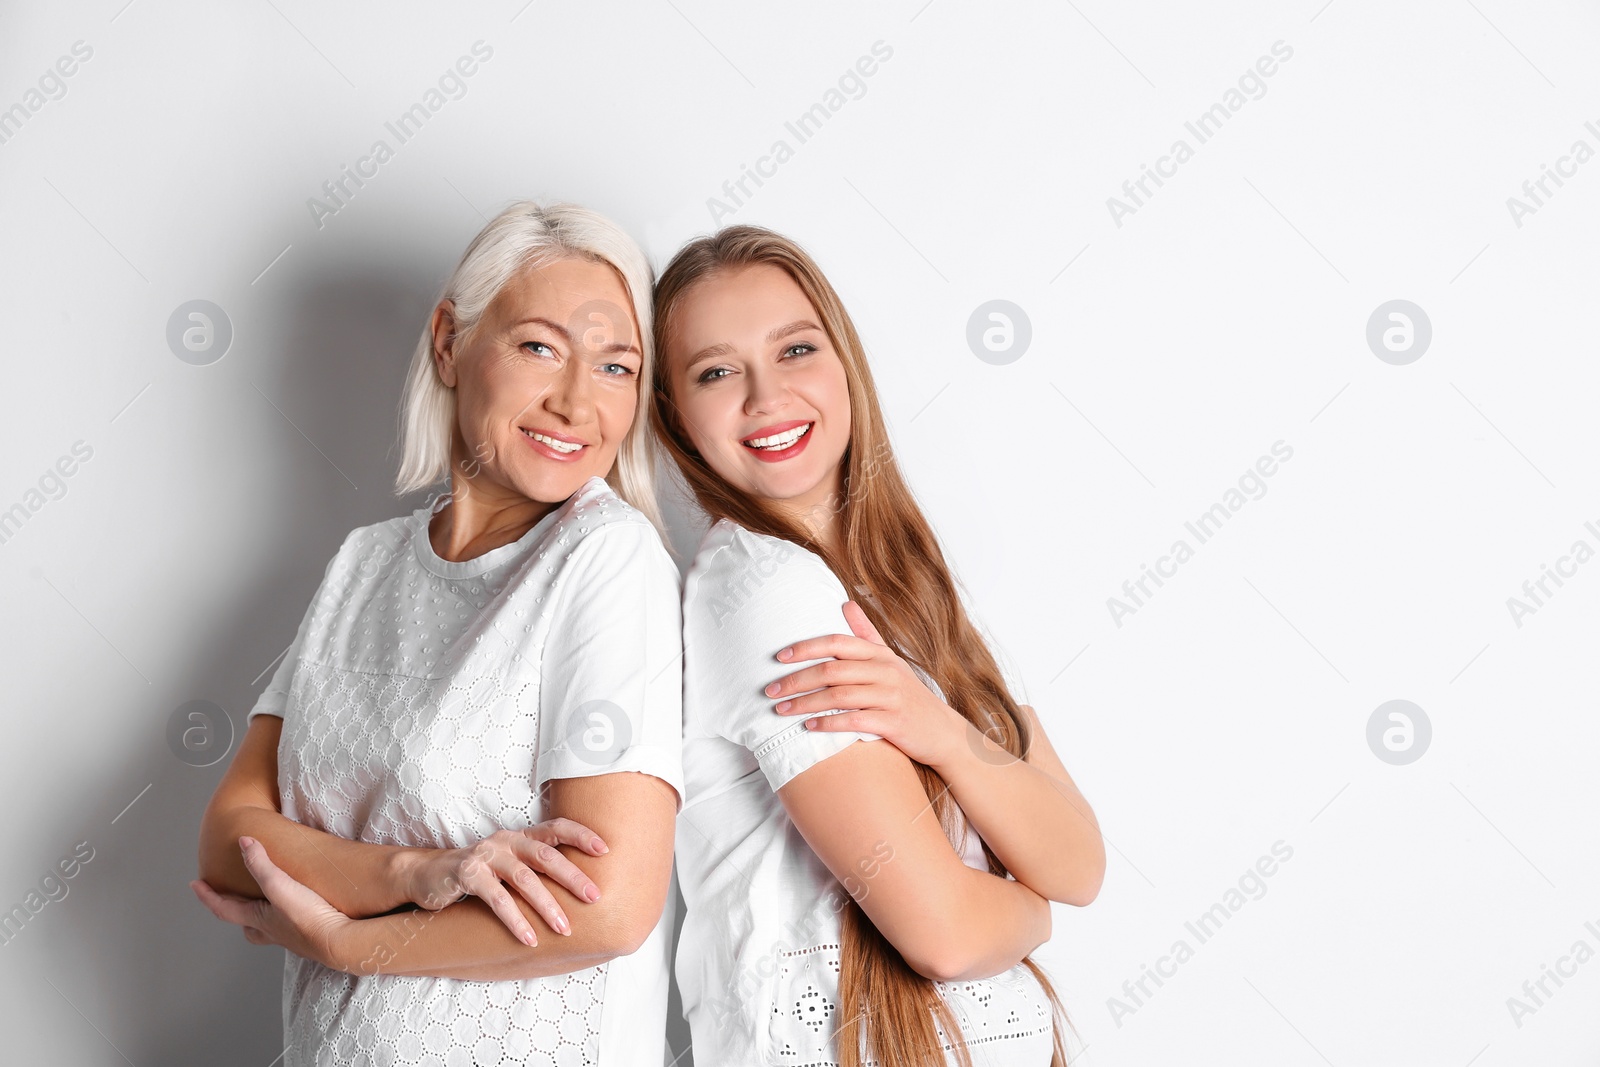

{"left": 765, "top": 605, "right": 1106, "bottom": 981}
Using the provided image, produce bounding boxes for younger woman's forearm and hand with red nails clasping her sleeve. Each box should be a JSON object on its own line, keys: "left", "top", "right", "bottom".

{"left": 768, "top": 603, "right": 1106, "bottom": 905}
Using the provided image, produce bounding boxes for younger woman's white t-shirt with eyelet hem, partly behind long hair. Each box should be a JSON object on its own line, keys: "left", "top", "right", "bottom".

{"left": 675, "top": 520, "right": 1051, "bottom": 1067}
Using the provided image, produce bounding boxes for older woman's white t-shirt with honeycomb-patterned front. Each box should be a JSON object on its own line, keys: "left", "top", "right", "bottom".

{"left": 250, "top": 477, "right": 683, "bottom": 1067}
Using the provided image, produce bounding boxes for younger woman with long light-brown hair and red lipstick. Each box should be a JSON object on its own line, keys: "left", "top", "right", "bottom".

{"left": 654, "top": 226, "right": 1106, "bottom": 1067}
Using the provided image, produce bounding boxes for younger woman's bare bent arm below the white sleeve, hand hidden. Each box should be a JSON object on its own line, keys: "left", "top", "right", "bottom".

{"left": 778, "top": 731, "right": 1050, "bottom": 981}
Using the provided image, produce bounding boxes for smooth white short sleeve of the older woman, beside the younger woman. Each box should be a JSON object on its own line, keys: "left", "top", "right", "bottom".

{"left": 534, "top": 522, "right": 683, "bottom": 809}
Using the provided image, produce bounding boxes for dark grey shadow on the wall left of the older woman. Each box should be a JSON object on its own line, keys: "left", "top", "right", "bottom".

{"left": 145, "top": 260, "right": 440, "bottom": 1067}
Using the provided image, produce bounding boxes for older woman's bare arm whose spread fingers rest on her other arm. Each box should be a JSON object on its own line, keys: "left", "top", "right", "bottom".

{"left": 200, "top": 715, "right": 605, "bottom": 939}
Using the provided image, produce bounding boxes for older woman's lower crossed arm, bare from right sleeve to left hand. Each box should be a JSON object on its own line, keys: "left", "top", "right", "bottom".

{"left": 195, "top": 773, "right": 677, "bottom": 981}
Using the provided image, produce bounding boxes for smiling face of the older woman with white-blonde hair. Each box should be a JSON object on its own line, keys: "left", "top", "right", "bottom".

{"left": 435, "top": 259, "right": 643, "bottom": 502}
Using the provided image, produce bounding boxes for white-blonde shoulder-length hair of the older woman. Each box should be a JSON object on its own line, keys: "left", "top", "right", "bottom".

{"left": 395, "top": 200, "right": 662, "bottom": 530}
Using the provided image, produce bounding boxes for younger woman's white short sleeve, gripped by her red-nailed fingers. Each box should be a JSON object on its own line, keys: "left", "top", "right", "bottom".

{"left": 683, "top": 530, "right": 880, "bottom": 792}
